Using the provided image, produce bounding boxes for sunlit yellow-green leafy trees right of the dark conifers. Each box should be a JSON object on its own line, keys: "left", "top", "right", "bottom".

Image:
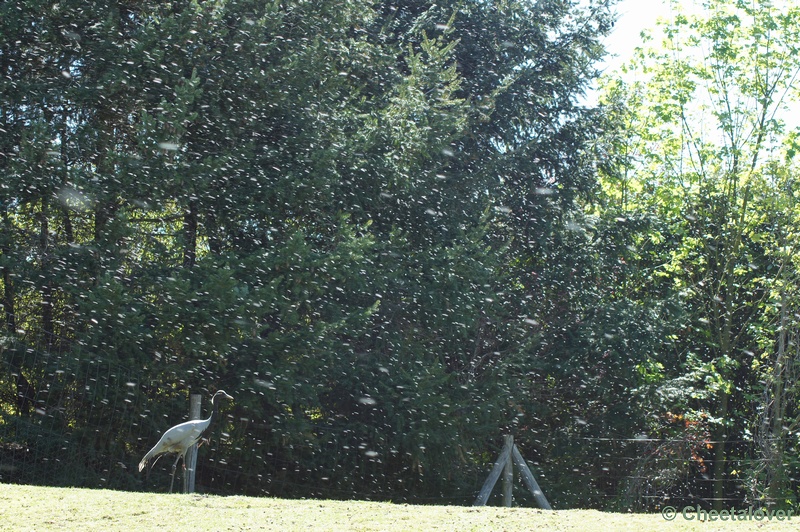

{"left": 604, "top": 0, "right": 800, "bottom": 508}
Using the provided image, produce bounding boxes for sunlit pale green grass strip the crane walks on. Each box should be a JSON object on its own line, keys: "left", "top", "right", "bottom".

{"left": 0, "top": 484, "right": 800, "bottom": 532}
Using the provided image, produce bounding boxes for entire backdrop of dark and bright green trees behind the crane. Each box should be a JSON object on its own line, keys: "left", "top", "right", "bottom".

{"left": 6, "top": 0, "right": 800, "bottom": 509}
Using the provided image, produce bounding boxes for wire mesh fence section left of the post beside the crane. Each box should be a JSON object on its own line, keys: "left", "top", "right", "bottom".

{"left": 0, "top": 332, "right": 146, "bottom": 489}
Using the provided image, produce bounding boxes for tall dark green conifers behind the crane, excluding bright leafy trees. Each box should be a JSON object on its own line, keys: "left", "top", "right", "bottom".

{"left": 0, "top": 0, "right": 627, "bottom": 508}
